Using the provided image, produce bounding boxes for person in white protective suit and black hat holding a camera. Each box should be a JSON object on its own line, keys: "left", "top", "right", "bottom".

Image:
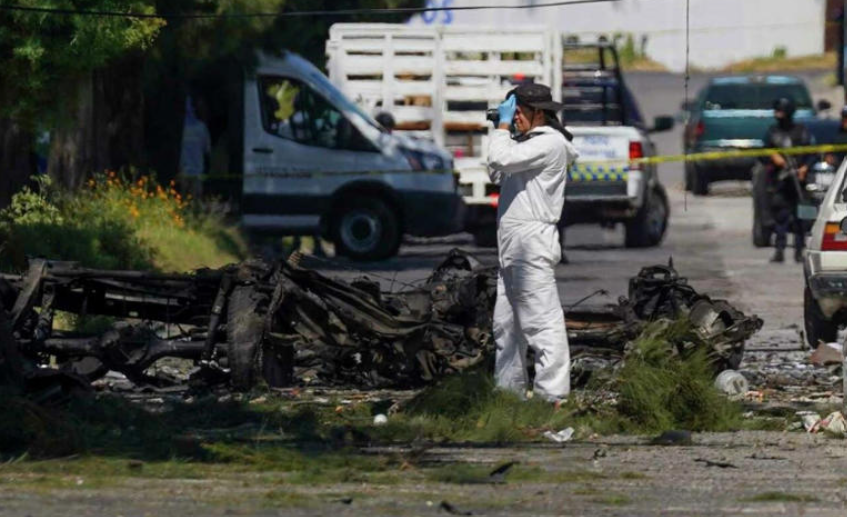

{"left": 488, "top": 84, "right": 578, "bottom": 402}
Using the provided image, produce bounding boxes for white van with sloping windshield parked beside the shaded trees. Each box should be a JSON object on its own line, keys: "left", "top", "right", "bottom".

{"left": 242, "top": 52, "right": 463, "bottom": 260}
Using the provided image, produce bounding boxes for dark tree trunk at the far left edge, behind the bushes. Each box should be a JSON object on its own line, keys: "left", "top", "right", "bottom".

{"left": 0, "top": 118, "right": 35, "bottom": 208}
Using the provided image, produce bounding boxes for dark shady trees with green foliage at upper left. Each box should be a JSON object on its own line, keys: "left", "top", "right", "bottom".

{"left": 0, "top": 0, "right": 424, "bottom": 191}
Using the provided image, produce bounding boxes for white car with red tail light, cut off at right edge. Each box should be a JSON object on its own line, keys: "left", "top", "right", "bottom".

{"left": 803, "top": 155, "right": 847, "bottom": 347}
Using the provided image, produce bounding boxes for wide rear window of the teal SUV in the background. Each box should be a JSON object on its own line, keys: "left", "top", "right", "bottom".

{"left": 704, "top": 83, "right": 812, "bottom": 110}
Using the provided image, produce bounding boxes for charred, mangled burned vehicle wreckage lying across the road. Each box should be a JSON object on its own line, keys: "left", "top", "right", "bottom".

{"left": 0, "top": 250, "right": 762, "bottom": 391}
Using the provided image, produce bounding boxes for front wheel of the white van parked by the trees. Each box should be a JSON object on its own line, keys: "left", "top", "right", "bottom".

{"left": 332, "top": 197, "right": 403, "bottom": 260}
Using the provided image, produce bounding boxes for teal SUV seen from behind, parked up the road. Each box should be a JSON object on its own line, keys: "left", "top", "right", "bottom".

{"left": 683, "top": 75, "right": 830, "bottom": 196}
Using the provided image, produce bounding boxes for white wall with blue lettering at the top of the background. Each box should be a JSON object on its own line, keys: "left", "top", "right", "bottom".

{"left": 410, "top": 0, "right": 826, "bottom": 71}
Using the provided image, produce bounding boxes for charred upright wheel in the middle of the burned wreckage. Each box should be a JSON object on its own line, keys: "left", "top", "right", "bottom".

{"left": 226, "top": 285, "right": 267, "bottom": 391}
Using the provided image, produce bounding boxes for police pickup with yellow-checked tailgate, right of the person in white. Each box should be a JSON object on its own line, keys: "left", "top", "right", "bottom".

{"left": 561, "top": 43, "right": 674, "bottom": 248}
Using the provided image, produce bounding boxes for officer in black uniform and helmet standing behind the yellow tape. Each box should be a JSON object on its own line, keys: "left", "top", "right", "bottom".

{"left": 765, "top": 97, "right": 812, "bottom": 262}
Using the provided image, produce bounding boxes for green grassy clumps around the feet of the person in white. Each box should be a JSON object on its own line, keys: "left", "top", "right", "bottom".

{"left": 376, "top": 322, "right": 744, "bottom": 443}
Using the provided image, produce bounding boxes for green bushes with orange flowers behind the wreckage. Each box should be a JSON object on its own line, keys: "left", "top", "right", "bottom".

{"left": 0, "top": 172, "right": 247, "bottom": 271}
